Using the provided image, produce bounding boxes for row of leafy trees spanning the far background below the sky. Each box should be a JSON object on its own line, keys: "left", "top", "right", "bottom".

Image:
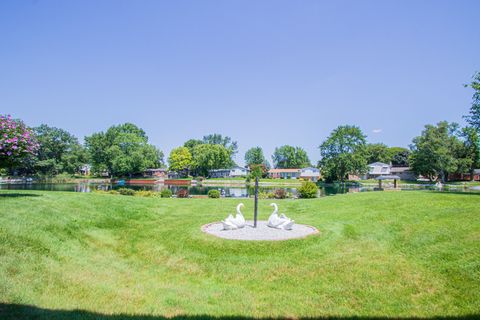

{"left": 0, "top": 73, "right": 480, "bottom": 181}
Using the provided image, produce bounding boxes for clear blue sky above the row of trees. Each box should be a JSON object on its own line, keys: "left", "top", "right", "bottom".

{"left": 0, "top": 0, "right": 480, "bottom": 164}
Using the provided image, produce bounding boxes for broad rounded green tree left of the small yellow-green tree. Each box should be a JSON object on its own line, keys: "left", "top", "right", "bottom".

{"left": 85, "top": 123, "right": 163, "bottom": 177}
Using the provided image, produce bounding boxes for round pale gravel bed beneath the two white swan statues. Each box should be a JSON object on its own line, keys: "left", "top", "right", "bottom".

{"left": 202, "top": 220, "right": 318, "bottom": 241}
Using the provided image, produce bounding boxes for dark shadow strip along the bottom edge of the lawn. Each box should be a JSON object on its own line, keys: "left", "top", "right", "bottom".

{"left": 0, "top": 303, "right": 480, "bottom": 320}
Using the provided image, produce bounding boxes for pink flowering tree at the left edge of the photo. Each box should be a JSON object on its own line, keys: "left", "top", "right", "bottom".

{"left": 0, "top": 115, "right": 38, "bottom": 168}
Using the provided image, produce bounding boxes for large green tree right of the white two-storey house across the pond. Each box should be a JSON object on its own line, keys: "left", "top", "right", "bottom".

{"left": 410, "top": 121, "right": 461, "bottom": 182}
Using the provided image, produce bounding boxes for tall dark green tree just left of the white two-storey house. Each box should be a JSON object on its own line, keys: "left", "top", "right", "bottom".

{"left": 320, "top": 125, "right": 367, "bottom": 182}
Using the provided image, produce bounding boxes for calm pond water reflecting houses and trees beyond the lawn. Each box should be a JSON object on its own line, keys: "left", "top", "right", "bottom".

{"left": 0, "top": 183, "right": 480, "bottom": 198}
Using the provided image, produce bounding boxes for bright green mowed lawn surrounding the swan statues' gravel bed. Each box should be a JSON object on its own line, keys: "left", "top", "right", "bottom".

{"left": 0, "top": 191, "right": 480, "bottom": 320}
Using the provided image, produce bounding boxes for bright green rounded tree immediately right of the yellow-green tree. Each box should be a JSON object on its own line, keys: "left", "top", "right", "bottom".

{"left": 193, "top": 144, "right": 232, "bottom": 176}
